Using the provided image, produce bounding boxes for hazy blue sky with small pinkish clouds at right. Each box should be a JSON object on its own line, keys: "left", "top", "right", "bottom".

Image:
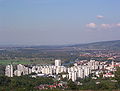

{"left": 0, "top": 0, "right": 120, "bottom": 45}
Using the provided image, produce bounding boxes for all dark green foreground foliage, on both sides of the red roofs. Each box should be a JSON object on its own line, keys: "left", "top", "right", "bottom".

{"left": 0, "top": 68, "right": 120, "bottom": 91}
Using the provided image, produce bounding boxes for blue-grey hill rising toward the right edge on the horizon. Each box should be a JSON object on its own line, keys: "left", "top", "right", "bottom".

{"left": 70, "top": 40, "right": 120, "bottom": 50}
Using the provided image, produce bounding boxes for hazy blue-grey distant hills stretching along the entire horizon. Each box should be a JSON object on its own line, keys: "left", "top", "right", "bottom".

{"left": 0, "top": 40, "right": 120, "bottom": 50}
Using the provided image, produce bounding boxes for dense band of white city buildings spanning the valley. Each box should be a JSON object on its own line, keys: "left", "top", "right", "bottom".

{"left": 5, "top": 60, "right": 120, "bottom": 81}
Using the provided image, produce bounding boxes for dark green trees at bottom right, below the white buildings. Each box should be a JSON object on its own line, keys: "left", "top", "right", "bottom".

{"left": 68, "top": 78, "right": 119, "bottom": 91}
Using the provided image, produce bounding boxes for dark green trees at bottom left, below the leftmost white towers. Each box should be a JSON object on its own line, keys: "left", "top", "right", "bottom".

{"left": 0, "top": 76, "right": 54, "bottom": 91}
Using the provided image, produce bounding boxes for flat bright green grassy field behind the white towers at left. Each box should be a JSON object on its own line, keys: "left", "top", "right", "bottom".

{"left": 0, "top": 60, "right": 54, "bottom": 65}
